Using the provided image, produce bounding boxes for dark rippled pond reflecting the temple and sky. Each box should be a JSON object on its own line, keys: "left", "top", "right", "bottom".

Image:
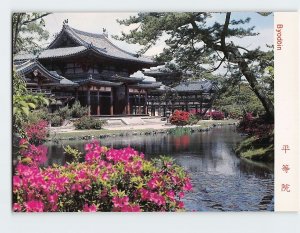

{"left": 46, "top": 126, "right": 274, "bottom": 211}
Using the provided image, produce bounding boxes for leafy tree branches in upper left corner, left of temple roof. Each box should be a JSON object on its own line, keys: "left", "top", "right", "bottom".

{"left": 12, "top": 13, "right": 50, "bottom": 54}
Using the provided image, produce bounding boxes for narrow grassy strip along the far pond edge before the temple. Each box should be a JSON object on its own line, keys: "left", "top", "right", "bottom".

{"left": 48, "top": 120, "right": 236, "bottom": 140}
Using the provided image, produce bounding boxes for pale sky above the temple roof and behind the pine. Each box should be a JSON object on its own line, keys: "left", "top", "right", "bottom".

{"left": 45, "top": 12, "right": 273, "bottom": 56}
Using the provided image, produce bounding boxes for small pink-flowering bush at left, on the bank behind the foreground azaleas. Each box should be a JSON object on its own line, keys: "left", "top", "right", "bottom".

{"left": 25, "top": 120, "right": 48, "bottom": 145}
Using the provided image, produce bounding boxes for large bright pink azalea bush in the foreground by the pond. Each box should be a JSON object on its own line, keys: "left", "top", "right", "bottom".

{"left": 13, "top": 141, "right": 192, "bottom": 212}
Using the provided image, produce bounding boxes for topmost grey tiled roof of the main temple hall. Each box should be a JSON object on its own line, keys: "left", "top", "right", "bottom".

{"left": 48, "top": 25, "right": 154, "bottom": 64}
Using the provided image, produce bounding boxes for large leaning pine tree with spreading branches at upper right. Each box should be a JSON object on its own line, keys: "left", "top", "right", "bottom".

{"left": 115, "top": 12, "right": 274, "bottom": 119}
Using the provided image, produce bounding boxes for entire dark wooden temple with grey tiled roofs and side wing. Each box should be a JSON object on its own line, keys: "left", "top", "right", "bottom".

{"left": 13, "top": 24, "right": 215, "bottom": 116}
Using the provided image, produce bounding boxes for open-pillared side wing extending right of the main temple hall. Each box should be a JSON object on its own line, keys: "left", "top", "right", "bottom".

{"left": 143, "top": 68, "right": 218, "bottom": 116}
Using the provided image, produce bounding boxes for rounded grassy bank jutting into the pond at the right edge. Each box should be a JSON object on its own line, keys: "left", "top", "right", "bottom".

{"left": 235, "top": 134, "right": 274, "bottom": 162}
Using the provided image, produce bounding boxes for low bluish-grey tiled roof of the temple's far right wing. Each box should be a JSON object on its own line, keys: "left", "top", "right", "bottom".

{"left": 174, "top": 80, "right": 216, "bottom": 92}
